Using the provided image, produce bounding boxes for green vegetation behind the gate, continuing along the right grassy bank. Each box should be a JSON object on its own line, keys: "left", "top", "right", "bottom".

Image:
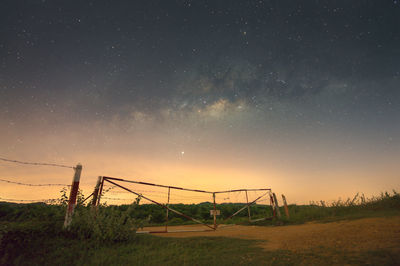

{"left": 109, "top": 191, "right": 400, "bottom": 226}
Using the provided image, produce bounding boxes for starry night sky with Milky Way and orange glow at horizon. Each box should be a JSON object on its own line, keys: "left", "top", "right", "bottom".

{"left": 0, "top": 0, "right": 400, "bottom": 202}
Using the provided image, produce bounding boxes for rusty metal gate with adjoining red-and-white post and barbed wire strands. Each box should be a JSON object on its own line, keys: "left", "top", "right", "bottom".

{"left": 0, "top": 157, "right": 288, "bottom": 232}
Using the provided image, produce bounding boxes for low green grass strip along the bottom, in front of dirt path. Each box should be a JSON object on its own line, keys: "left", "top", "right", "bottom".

{"left": 0, "top": 227, "right": 400, "bottom": 265}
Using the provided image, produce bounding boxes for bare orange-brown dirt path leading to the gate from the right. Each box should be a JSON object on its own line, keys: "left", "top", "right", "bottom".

{"left": 145, "top": 216, "right": 400, "bottom": 251}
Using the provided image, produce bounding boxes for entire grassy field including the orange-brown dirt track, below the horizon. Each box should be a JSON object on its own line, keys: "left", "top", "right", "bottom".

{"left": 0, "top": 193, "right": 400, "bottom": 265}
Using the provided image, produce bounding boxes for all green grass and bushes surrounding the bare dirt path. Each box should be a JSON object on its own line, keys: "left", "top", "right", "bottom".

{"left": 0, "top": 192, "right": 400, "bottom": 265}
